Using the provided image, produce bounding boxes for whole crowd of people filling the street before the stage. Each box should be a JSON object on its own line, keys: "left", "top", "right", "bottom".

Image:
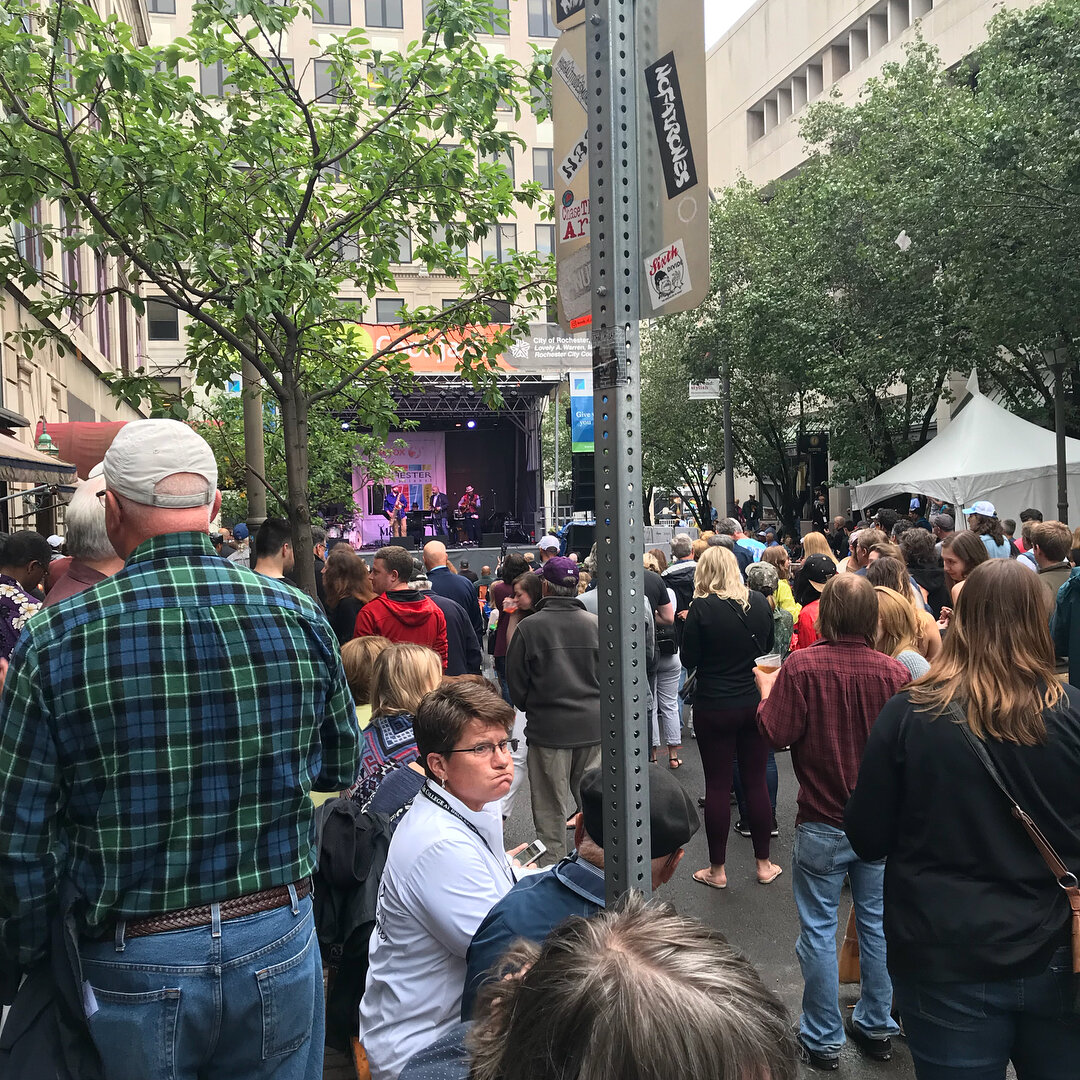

{"left": 0, "top": 436, "right": 1080, "bottom": 1080}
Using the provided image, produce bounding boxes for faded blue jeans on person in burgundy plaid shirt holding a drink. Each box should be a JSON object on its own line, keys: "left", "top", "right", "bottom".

{"left": 792, "top": 822, "right": 900, "bottom": 1054}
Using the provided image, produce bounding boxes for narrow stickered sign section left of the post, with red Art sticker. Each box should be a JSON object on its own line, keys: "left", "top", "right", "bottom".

{"left": 551, "top": 25, "right": 593, "bottom": 334}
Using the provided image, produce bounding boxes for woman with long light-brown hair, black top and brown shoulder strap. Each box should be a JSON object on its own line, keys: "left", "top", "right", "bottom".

{"left": 845, "top": 558, "right": 1080, "bottom": 1080}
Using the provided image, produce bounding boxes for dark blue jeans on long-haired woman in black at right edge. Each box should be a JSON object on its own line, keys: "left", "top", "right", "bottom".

{"left": 895, "top": 946, "right": 1080, "bottom": 1080}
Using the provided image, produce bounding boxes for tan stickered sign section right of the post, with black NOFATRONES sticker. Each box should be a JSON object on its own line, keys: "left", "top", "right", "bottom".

{"left": 635, "top": 0, "right": 710, "bottom": 319}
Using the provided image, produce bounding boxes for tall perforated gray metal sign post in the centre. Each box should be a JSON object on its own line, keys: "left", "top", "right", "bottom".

{"left": 585, "top": 0, "right": 651, "bottom": 905}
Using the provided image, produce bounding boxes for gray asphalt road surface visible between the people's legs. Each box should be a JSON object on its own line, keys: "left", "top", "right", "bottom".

{"left": 505, "top": 725, "right": 915, "bottom": 1080}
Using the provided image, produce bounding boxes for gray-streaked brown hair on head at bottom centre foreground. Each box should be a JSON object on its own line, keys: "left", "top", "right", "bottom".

{"left": 468, "top": 892, "right": 799, "bottom": 1080}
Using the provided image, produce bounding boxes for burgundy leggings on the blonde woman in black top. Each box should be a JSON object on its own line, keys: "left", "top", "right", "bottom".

{"left": 693, "top": 704, "right": 772, "bottom": 866}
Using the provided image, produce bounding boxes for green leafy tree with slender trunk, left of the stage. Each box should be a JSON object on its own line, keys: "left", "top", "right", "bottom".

{"left": 0, "top": 0, "right": 550, "bottom": 591}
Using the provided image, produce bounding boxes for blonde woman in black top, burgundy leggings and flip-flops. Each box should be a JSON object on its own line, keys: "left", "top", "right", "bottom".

{"left": 683, "top": 548, "right": 781, "bottom": 889}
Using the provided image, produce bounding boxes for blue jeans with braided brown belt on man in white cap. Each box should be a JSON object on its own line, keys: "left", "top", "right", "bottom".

{"left": 79, "top": 897, "right": 324, "bottom": 1080}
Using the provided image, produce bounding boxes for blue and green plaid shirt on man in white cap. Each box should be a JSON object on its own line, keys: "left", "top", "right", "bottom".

{"left": 0, "top": 532, "right": 360, "bottom": 964}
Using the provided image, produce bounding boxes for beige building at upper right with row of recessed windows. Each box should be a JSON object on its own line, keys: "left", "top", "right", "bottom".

{"left": 706, "top": 0, "right": 1037, "bottom": 188}
